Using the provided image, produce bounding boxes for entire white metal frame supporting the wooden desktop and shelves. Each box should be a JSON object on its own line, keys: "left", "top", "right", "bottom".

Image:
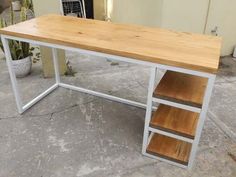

{"left": 1, "top": 35, "right": 215, "bottom": 168}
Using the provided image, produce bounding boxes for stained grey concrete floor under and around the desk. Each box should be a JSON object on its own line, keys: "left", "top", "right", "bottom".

{"left": 0, "top": 49, "right": 236, "bottom": 177}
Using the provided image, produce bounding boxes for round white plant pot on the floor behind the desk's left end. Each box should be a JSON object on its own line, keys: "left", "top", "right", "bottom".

{"left": 12, "top": 57, "right": 32, "bottom": 78}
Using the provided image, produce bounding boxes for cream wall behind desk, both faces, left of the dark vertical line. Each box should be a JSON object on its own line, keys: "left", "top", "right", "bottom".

{"left": 112, "top": 0, "right": 208, "bottom": 33}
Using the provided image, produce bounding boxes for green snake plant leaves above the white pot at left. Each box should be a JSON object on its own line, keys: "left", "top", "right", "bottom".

{"left": 0, "top": 0, "right": 40, "bottom": 61}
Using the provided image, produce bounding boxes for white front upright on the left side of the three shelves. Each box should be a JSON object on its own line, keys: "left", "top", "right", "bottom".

{"left": 142, "top": 67, "right": 156, "bottom": 155}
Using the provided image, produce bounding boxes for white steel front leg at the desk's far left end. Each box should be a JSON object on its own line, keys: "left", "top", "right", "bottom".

{"left": 1, "top": 37, "right": 23, "bottom": 114}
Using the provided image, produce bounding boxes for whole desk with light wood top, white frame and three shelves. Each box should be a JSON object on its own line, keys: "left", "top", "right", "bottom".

{"left": 0, "top": 15, "right": 221, "bottom": 168}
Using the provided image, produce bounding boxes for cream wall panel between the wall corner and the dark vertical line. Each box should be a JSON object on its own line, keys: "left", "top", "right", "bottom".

{"left": 162, "top": 0, "right": 208, "bottom": 33}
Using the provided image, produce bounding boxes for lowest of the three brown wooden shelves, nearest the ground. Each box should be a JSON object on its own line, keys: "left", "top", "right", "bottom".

{"left": 147, "top": 134, "right": 192, "bottom": 165}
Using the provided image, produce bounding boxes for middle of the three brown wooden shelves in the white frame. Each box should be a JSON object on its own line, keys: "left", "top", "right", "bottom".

{"left": 150, "top": 105, "right": 199, "bottom": 139}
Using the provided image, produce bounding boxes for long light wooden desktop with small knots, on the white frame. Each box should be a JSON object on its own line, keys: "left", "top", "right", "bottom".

{"left": 0, "top": 15, "right": 221, "bottom": 73}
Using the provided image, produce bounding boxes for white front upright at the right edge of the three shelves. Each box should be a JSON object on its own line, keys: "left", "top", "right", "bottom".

{"left": 188, "top": 75, "right": 216, "bottom": 168}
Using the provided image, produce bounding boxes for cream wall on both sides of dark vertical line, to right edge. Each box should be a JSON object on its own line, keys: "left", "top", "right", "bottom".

{"left": 161, "top": 0, "right": 236, "bottom": 56}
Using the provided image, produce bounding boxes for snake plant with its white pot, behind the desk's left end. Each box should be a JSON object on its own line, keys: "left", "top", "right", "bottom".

{"left": 0, "top": 7, "right": 39, "bottom": 77}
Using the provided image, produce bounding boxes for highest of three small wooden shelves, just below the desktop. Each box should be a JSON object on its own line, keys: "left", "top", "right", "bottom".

{"left": 153, "top": 71, "right": 207, "bottom": 108}
